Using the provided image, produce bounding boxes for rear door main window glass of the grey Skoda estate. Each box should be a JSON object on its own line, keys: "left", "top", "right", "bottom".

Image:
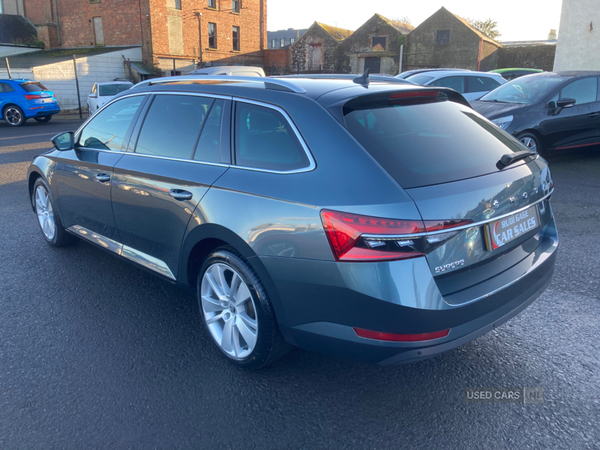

{"left": 135, "top": 95, "right": 213, "bottom": 159}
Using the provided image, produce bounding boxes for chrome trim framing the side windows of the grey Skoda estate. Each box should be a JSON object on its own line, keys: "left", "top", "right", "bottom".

{"left": 74, "top": 91, "right": 317, "bottom": 175}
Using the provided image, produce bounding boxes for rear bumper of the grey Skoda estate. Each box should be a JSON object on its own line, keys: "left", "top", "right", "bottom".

{"left": 261, "top": 216, "right": 558, "bottom": 365}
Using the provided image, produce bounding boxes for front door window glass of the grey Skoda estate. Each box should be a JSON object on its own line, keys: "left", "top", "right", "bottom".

{"left": 77, "top": 95, "right": 144, "bottom": 151}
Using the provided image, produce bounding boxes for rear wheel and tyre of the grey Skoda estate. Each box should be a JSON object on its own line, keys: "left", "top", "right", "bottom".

{"left": 197, "top": 248, "right": 291, "bottom": 370}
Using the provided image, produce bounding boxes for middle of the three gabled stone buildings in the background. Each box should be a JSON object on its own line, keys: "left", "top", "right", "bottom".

{"left": 341, "top": 14, "right": 415, "bottom": 75}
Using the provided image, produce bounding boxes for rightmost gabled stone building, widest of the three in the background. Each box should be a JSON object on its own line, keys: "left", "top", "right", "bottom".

{"left": 403, "top": 7, "right": 501, "bottom": 71}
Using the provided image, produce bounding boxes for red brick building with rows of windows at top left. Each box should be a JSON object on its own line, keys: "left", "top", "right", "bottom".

{"left": 24, "top": 0, "right": 267, "bottom": 72}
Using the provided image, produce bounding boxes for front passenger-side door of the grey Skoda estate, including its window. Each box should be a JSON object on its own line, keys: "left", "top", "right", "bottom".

{"left": 50, "top": 95, "right": 146, "bottom": 245}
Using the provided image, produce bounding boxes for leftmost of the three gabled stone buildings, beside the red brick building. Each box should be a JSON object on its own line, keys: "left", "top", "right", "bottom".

{"left": 290, "top": 22, "right": 352, "bottom": 72}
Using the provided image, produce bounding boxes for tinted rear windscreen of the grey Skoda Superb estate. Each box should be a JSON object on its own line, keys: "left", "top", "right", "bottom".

{"left": 344, "top": 101, "right": 526, "bottom": 189}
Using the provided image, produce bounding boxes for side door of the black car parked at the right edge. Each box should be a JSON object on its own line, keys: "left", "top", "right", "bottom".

{"left": 540, "top": 77, "right": 600, "bottom": 148}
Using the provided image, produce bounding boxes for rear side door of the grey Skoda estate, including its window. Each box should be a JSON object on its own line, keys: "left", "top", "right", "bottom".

{"left": 112, "top": 93, "right": 231, "bottom": 279}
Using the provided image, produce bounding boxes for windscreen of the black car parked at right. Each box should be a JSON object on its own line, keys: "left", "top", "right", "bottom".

{"left": 479, "top": 75, "right": 564, "bottom": 104}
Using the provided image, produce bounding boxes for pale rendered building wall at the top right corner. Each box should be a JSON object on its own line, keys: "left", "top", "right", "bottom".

{"left": 554, "top": 0, "right": 600, "bottom": 71}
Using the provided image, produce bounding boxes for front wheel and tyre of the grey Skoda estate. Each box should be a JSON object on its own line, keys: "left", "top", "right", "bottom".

{"left": 31, "top": 178, "right": 76, "bottom": 247}
